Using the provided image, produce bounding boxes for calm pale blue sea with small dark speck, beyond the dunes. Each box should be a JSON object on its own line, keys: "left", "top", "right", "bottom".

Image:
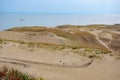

{"left": 0, "top": 13, "right": 120, "bottom": 30}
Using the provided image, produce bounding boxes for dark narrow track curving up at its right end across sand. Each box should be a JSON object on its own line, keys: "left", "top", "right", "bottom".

{"left": 0, "top": 57, "right": 94, "bottom": 68}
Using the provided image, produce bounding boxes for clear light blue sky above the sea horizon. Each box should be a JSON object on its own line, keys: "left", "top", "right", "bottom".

{"left": 0, "top": 0, "right": 120, "bottom": 14}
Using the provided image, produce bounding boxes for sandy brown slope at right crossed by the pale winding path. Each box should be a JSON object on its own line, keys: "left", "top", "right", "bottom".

{"left": 79, "top": 27, "right": 120, "bottom": 52}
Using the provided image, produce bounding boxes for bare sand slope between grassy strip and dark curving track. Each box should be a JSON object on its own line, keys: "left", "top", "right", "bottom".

{"left": 0, "top": 43, "right": 90, "bottom": 66}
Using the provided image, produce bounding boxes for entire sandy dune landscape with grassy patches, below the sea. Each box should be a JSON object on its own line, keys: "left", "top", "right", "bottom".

{"left": 0, "top": 25, "right": 120, "bottom": 80}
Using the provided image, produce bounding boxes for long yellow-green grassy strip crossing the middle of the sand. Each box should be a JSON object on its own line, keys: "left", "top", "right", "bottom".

{"left": 2, "top": 39, "right": 110, "bottom": 58}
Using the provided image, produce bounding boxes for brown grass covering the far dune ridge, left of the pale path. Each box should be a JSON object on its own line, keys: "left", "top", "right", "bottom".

{"left": 3, "top": 24, "right": 114, "bottom": 51}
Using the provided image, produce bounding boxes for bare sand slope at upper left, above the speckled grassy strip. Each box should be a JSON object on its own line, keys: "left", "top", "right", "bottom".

{"left": 0, "top": 31, "right": 69, "bottom": 44}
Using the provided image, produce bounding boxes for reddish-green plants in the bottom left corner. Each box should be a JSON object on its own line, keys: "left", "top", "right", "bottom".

{"left": 0, "top": 66, "right": 43, "bottom": 80}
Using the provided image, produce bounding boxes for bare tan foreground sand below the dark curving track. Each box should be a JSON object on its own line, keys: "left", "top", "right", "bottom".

{"left": 0, "top": 59, "right": 120, "bottom": 80}
